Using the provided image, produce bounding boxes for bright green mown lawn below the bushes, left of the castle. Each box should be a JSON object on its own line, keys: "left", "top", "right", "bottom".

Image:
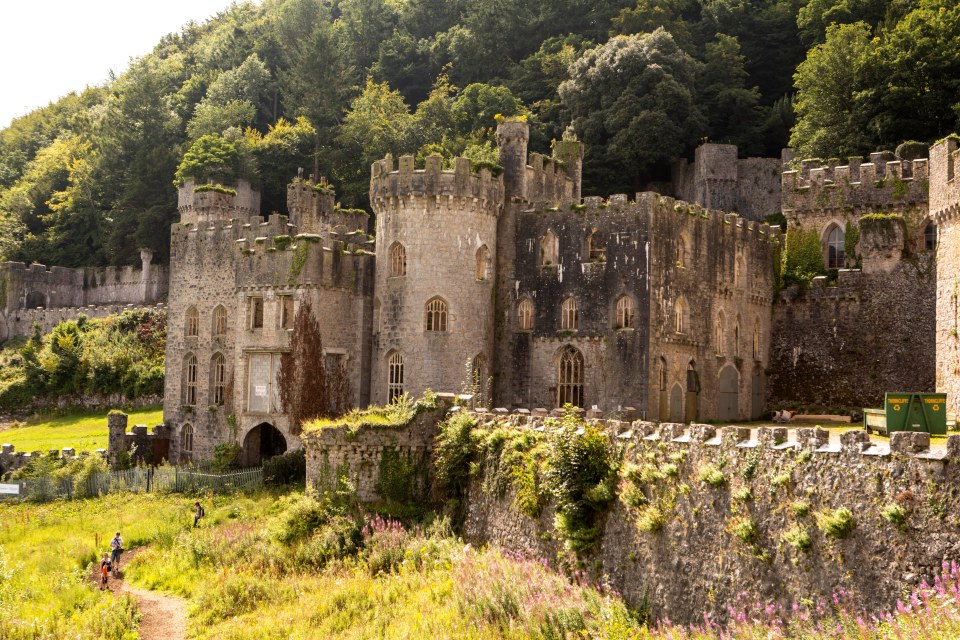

{"left": 0, "top": 407, "right": 163, "bottom": 452}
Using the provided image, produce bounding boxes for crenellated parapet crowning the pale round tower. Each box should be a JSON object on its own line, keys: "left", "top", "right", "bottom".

{"left": 370, "top": 156, "right": 503, "bottom": 215}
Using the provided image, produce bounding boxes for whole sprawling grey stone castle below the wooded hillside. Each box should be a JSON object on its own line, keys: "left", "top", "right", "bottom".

{"left": 0, "top": 121, "right": 960, "bottom": 463}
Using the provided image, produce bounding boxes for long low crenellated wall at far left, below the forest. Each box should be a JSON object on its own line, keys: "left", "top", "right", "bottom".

{"left": 0, "top": 251, "right": 169, "bottom": 342}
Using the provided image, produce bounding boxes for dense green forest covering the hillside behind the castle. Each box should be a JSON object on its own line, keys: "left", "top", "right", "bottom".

{"left": 0, "top": 0, "right": 960, "bottom": 266}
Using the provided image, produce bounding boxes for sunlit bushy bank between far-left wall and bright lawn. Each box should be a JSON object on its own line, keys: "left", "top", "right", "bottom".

{"left": 0, "top": 310, "right": 167, "bottom": 410}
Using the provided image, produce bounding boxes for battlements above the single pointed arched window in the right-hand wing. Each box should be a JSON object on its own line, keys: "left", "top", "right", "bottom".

{"left": 781, "top": 152, "right": 929, "bottom": 216}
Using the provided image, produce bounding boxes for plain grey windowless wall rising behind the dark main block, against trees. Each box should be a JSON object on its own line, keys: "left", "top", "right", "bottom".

{"left": 669, "top": 143, "right": 783, "bottom": 221}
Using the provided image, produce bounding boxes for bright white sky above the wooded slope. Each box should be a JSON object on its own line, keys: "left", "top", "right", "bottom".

{"left": 0, "top": 0, "right": 251, "bottom": 128}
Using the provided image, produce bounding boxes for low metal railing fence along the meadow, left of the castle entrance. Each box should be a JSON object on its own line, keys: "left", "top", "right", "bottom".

{"left": 0, "top": 467, "right": 263, "bottom": 502}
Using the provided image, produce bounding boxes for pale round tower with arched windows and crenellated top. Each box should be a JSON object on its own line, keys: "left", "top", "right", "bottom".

{"left": 370, "top": 156, "right": 503, "bottom": 404}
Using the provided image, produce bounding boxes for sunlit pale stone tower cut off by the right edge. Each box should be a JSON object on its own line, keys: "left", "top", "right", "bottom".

{"left": 930, "top": 138, "right": 960, "bottom": 412}
